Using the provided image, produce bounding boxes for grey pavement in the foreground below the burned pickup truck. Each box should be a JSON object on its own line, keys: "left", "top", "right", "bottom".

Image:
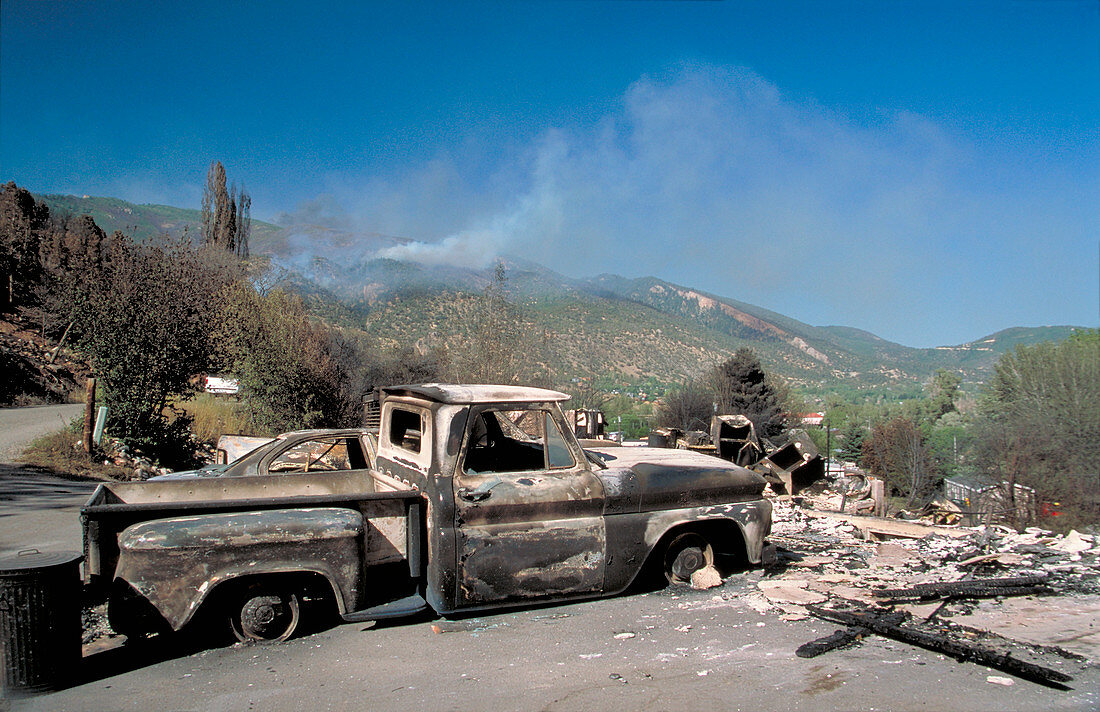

{"left": 12, "top": 571, "right": 1100, "bottom": 712}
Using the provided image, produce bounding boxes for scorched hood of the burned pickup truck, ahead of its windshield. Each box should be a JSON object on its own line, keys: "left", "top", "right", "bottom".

{"left": 587, "top": 448, "right": 766, "bottom": 514}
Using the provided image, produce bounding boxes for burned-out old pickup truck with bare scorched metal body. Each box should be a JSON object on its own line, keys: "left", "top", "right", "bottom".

{"left": 81, "top": 384, "right": 771, "bottom": 640}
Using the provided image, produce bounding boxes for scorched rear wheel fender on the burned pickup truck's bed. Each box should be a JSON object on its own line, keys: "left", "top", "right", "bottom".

{"left": 116, "top": 507, "right": 366, "bottom": 631}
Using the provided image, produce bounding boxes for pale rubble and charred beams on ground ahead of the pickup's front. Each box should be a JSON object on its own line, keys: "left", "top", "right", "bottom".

{"left": 749, "top": 494, "right": 1100, "bottom": 689}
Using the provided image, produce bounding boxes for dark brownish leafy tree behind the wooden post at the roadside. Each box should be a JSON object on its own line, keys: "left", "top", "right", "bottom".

{"left": 51, "top": 234, "right": 235, "bottom": 462}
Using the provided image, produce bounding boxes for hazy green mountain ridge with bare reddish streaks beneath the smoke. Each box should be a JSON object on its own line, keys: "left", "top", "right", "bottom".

{"left": 36, "top": 195, "right": 1079, "bottom": 388}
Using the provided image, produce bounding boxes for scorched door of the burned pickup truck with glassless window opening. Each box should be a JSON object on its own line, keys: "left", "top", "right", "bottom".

{"left": 453, "top": 405, "right": 607, "bottom": 606}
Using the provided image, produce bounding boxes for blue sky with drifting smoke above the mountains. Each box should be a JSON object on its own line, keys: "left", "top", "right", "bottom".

{"left": 0, "top": 0, "right": 1100, "bottom": 346}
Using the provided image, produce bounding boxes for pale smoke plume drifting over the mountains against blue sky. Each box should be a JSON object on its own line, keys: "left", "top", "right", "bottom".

{"left": 270, "top": 65, "right": 1100, "bottom": 346}
